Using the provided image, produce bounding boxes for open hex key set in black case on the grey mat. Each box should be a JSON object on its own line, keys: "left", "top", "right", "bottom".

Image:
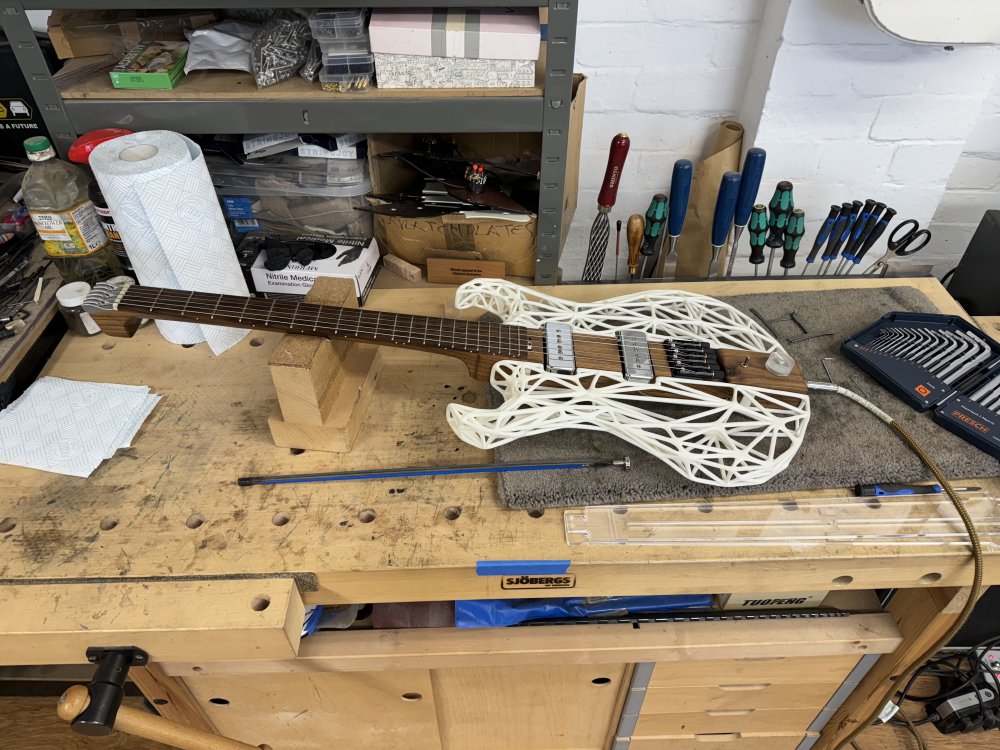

{"left": 842, "top": 312, "right": 1000, "bottom": 458}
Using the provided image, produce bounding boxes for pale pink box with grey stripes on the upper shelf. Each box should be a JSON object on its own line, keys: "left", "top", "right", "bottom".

{"left": 369, "top": 8, "right": 541, "bottom": 60}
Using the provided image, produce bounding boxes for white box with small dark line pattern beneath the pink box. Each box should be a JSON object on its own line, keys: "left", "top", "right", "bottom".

{"left": 375, "top": 52, "right": 535, "bottom": 89}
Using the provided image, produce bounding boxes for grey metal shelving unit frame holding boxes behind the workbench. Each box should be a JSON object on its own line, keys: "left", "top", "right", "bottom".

{"left": 0, "top": 0, "right": 579, "bottom": 284}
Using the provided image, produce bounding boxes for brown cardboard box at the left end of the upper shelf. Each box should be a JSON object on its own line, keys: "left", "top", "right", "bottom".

{"left": 48, "top": 10, "right": 218, "bottom": 60}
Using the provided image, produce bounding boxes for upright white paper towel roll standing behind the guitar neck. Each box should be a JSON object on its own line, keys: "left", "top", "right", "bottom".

{"left": 90, "top": 130, "right": 250, "bottom": 354}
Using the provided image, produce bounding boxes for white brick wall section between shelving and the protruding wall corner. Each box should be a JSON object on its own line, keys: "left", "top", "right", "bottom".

{"left": 561, "top": 0, "right": 774, "bottom": 281}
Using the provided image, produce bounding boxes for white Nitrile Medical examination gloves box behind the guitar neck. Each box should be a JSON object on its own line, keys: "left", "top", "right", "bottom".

{"left": 250, "top": 235, "right": 381, "bottom": 305}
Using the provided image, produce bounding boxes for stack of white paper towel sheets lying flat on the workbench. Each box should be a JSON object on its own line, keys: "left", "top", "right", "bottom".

{"left": 0, "top": 378, "right": 160, "bottom": 477}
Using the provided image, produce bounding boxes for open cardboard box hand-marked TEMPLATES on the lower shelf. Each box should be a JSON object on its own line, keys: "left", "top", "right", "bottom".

{"left": 368, "top": 75, "right": 584, "bottom": 278}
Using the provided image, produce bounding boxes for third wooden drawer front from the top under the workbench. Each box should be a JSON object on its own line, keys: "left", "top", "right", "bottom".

{"left": 632, "top": 708, "right": 819, "bottom": 737}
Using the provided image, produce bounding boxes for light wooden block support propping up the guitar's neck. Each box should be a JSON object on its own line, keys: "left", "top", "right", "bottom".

{"left": 268, "top": 277, "right": 381, "bottom": 452}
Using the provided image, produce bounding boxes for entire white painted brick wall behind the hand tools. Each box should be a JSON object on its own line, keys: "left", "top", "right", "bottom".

{"left": 562, "top": 0, "right": 1000, "bottom": 281}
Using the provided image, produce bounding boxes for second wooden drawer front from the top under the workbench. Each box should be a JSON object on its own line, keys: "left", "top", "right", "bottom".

{"left": 641, "top": 682, "right": 838, "bottom": 714}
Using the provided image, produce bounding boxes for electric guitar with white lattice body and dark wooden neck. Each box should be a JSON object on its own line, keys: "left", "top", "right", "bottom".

{"left": 83, "top": 279, "right": 809, "bottom": 487}
